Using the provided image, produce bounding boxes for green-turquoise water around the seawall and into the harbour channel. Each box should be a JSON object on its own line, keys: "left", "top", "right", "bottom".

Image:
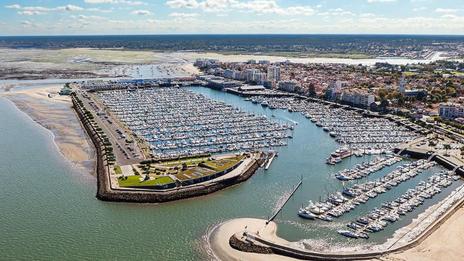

{"left": 0, "top": 88, "right": 458, "bottom": 260}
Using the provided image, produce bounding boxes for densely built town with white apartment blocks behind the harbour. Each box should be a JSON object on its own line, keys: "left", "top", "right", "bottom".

{"left": 195, "top": 59, "right": 464, "bottom": 137}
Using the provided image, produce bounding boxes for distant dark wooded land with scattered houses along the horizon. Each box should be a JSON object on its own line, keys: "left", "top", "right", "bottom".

{"left": 0, "top": 34, "right": 464, "bottom": 59}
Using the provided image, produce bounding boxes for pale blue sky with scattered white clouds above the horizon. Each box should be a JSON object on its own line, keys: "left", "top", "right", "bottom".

{"left": 0, "top": 0, "right": 464, "bottom": 35}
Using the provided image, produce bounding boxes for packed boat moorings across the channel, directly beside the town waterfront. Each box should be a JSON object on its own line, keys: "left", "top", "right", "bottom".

{"left": 251, "top": 96, "right": 419, "bottom": 158}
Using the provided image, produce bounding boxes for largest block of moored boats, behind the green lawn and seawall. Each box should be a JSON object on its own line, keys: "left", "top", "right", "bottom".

{"left": 97, "top": 88, "right": 294, "bottom": 158}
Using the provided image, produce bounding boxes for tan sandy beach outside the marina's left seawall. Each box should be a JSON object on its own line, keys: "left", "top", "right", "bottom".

{"left": 0, "top": 85, "right": 95, "bottom": 174}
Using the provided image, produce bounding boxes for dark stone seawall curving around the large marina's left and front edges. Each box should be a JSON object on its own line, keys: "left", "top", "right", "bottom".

{"left": 72, "top": 95, "right": 265, "bottom": 203}
